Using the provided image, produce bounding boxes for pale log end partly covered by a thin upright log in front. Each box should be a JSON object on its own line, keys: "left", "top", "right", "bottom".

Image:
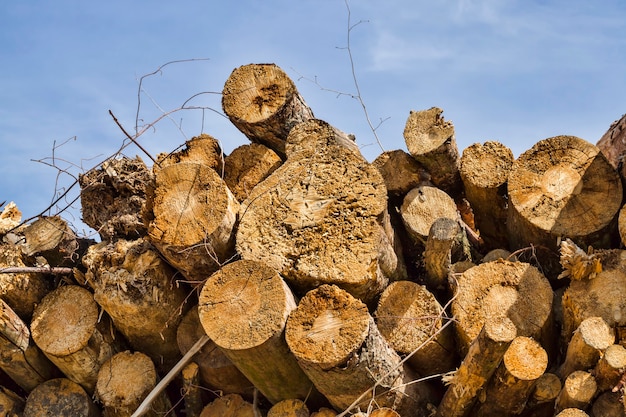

{"left": 400, "top": 186, "right": 458, "bottom": 246}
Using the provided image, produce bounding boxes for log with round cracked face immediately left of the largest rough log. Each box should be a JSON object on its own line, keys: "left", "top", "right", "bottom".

{"left": 146, "top": 162, "right": 239, "bottom": 282}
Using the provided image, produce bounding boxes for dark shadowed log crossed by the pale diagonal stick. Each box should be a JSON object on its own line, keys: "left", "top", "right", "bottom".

{"left": 176, "top": 307, "right": 254, "bottom": 399}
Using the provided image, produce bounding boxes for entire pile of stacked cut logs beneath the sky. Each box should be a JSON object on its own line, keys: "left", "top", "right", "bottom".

{"left": 0, "top": 64, "right": 626, "bottom": 417}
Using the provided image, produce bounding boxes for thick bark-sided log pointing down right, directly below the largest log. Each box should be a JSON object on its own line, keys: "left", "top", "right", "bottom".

{"left": 285, "top": 285, "right": 425, "bottom": 417}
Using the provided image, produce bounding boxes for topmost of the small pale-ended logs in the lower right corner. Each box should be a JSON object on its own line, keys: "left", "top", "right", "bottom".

{"left": 556, "top": 317, "right": 615, "bottom": 379}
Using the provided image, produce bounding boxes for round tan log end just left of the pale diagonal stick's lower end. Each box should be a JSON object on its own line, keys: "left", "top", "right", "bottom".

{"left": 96, "top": 351, "right": 171, "bottom": 417}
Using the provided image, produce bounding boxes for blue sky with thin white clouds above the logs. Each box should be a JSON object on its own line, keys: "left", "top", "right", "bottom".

{"left": 0, "top": 0, "right": 626, "bottom": 231}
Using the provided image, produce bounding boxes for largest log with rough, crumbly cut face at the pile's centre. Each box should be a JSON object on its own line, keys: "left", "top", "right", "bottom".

{"left": 237, "top": 138, "right": 406, "bottom": 300}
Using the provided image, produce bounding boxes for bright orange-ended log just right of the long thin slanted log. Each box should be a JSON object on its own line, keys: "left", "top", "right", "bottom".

{"left": 473, "top": 336, "right": 548, "bottom": 417}
